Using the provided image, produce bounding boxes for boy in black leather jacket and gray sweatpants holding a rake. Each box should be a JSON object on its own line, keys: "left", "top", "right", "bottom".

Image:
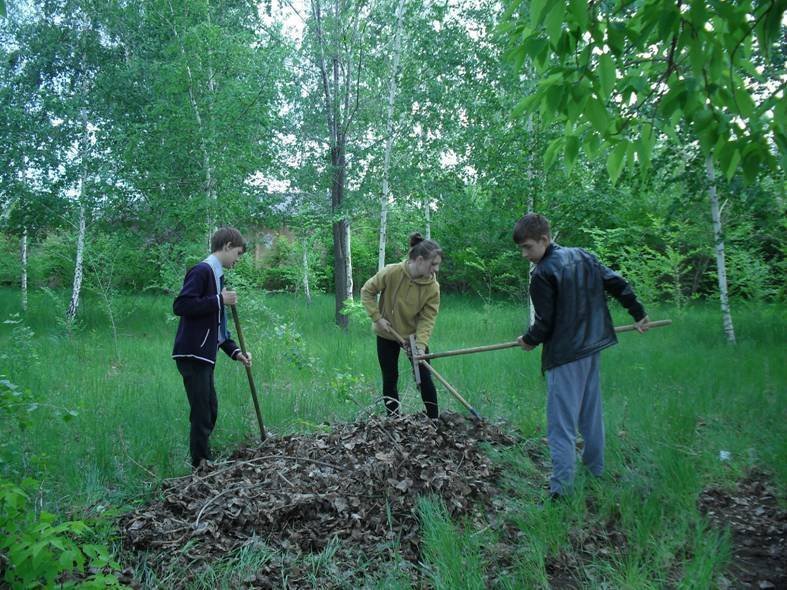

{"left": 513, "top": 213, "right": 648, "bottom": 497}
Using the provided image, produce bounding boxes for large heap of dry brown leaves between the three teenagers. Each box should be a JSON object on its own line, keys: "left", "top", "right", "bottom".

{"left": 122, "top": 413, "right": 528, "bottom": 588}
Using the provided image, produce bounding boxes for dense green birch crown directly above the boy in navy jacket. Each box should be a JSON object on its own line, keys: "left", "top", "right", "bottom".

{"left": 103, "top": 0, "right": 291, "bottom": 247}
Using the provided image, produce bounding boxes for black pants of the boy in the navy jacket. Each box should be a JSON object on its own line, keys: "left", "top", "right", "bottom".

{"left": 175, "top": 359, "right": 219, "bottom": 467}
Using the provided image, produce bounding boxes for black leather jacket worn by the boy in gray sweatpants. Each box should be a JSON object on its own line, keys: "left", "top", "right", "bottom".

{"left": 524, "top": 243, "right": 646, "bottom": 371}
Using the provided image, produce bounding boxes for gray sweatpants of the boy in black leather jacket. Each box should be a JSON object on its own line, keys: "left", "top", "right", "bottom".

{"left": 547, "top": 352, "right": 604, "bottom": 494}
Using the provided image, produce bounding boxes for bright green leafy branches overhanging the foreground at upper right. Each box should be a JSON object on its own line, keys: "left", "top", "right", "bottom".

{"left": 500, "top": 0, "right": 787, "bottom": 183}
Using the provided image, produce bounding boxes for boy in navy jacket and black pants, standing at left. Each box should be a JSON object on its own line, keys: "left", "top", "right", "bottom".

{"left": 172, "top": 227, "right": 251, "bottom": 467}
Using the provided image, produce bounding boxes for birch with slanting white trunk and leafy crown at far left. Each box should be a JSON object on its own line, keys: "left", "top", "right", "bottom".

{"left": 1, "top": 0, "right": 113, "bottom": 325}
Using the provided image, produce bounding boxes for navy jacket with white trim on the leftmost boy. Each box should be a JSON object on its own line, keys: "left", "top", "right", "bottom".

{"left": 172, "top": 262, "right": 240, "bottom": 365}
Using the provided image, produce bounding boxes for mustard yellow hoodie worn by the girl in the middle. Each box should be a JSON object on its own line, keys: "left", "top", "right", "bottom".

{"left": 361, "top": 260, "right": 440, "bottom": 349}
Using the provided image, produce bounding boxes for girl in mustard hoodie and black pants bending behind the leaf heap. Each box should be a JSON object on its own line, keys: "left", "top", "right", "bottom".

{"left": 361, "top": 233, "right": 443, "bottom": 420}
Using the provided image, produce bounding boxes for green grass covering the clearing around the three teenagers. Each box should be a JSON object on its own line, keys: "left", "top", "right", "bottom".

{"left": 0, "top": 289, "right": 787, "bottom": 588}
